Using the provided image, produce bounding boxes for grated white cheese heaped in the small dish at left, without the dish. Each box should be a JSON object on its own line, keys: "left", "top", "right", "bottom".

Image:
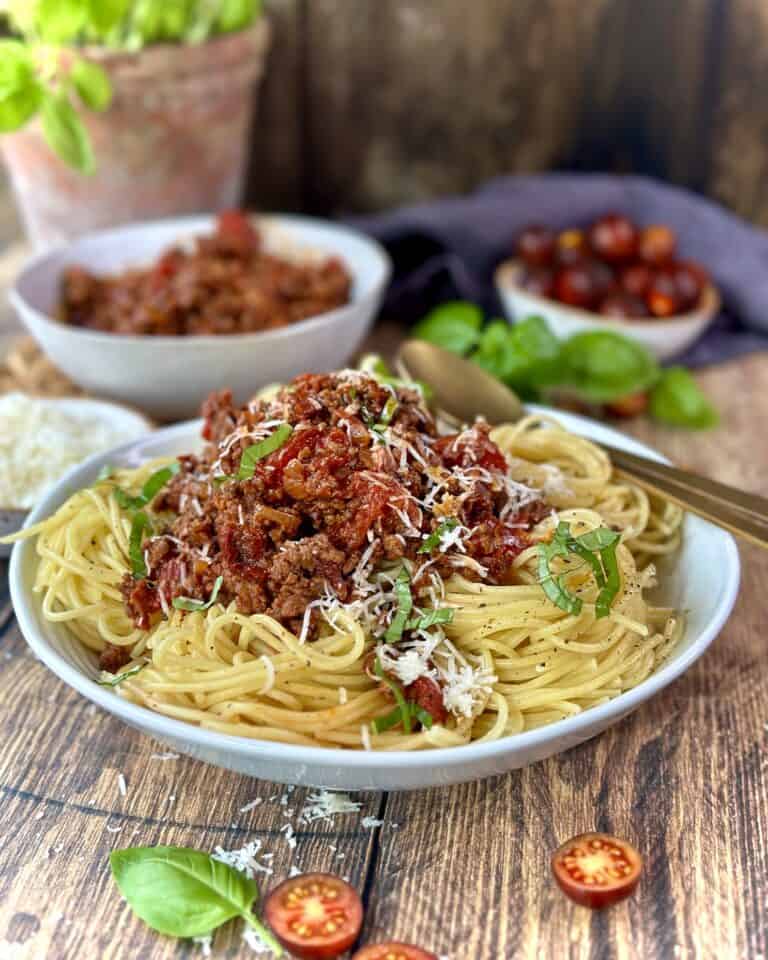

{"left": 0, "top": 393, "right": 143, "bottom": 510}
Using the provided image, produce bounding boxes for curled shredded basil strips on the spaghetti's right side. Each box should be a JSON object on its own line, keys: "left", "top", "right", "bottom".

{"left": 538, "top": 521, "right": 621, "bottom": 620}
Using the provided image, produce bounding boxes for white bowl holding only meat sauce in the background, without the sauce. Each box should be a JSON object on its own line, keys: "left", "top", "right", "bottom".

{"left": 9, "top": 215, "right": 391, "bottom": 420}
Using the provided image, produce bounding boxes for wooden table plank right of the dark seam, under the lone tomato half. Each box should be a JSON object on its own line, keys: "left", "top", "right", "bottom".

{"left": 367, "top": 355, "right": 768, "bottom": 960}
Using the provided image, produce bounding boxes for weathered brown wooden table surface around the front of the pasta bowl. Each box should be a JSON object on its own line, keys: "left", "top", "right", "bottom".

{"left": 0, "top": 312, "right": 768, "bottom": 960}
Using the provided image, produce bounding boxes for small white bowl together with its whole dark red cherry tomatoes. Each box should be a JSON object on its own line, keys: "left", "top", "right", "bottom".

{"left": 496, "top": 213, "right": 720, "bottom": 360}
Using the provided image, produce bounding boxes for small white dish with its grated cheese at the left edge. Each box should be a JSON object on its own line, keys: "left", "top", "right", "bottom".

{"left": 0, "top": 392, "right": 152, "bottom": 556}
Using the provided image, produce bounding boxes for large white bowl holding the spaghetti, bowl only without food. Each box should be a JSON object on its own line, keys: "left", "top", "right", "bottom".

{"left": 10, "top": 407, "right": 739, "bottom": 790}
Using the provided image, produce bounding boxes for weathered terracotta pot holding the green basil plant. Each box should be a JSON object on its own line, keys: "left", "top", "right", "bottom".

{"left": 0, "top": 18, "right": 269, "bottom": 250}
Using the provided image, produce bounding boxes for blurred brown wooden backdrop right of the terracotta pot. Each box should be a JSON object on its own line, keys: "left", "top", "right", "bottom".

{"left": 244, "top": 0, "right": 768, "bottom": 224}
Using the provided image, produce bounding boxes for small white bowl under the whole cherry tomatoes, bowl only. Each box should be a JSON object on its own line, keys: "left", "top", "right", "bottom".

{"left": 495, "top": 260, "right": 720, "bottom": 360}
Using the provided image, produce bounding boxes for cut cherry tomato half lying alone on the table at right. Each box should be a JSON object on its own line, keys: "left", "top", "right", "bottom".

{"left": 552, "top": 833, "right": 643, "bottom": 910}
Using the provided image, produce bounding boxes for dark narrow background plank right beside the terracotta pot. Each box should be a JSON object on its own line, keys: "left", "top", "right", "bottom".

{"left": 246, "top": 0, "right": 305, "bottom": 211}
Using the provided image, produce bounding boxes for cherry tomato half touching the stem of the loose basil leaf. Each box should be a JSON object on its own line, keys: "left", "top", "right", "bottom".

{"left": 264, "top": 873, "right": 363, "bottom": 960}
